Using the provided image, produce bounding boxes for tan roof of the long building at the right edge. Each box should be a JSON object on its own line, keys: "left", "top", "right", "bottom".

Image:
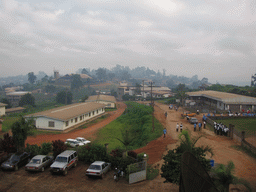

{"left": 186, "top": 90, "right": 256, "bottom": 105}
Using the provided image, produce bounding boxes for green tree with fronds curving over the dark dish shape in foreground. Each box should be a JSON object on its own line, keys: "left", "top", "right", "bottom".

{"left": 161, "top": 130, "right": 213, "bottom": 184}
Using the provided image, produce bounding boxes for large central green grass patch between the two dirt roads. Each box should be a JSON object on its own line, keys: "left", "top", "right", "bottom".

{"left": 95, "top": 102, "right": 163, "bottom": 151}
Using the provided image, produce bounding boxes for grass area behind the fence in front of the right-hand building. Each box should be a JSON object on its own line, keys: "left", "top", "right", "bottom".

{"left": 215, "top": 118, "right": 256, "bottom": 135}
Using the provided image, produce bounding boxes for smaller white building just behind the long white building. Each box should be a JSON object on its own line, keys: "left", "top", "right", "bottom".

{"left": 86, "top": 95, "right": 116, "bottom": 108}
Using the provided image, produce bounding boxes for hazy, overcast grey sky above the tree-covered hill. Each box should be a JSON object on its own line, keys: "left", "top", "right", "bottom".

{"left": 0, "top": 0, "right": 256, "bottom": 83}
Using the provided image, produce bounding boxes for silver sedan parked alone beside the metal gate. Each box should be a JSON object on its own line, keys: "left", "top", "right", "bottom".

{"left": 86, "top": 161, "right": 111, "bottom": 178}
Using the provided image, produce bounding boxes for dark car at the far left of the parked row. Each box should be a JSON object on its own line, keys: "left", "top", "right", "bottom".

{"left": 1, "top": 152, "right": 30, "bottom": 171}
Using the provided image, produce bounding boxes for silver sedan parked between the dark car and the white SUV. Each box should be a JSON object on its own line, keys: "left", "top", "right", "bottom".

{"left": 25, "top": 155, "right": 54, "bottom": 172}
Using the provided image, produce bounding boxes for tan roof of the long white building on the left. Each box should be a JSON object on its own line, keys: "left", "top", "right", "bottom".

{"left": 26, "top": 102, "right": 105, "bottom": 121}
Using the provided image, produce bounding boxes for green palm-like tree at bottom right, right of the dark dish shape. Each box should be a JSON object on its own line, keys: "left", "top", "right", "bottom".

{"left": 211, "top": 161, "right": 251, "bottom": 192}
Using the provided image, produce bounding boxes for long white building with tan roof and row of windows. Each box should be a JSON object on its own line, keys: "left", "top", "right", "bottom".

{"left": 25, "top": 102, "right": 105, "bottom": 131}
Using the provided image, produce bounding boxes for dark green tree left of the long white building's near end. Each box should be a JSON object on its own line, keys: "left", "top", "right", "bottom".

{"left": 11, "top": 116, "right": 35, "bottom": 151}
